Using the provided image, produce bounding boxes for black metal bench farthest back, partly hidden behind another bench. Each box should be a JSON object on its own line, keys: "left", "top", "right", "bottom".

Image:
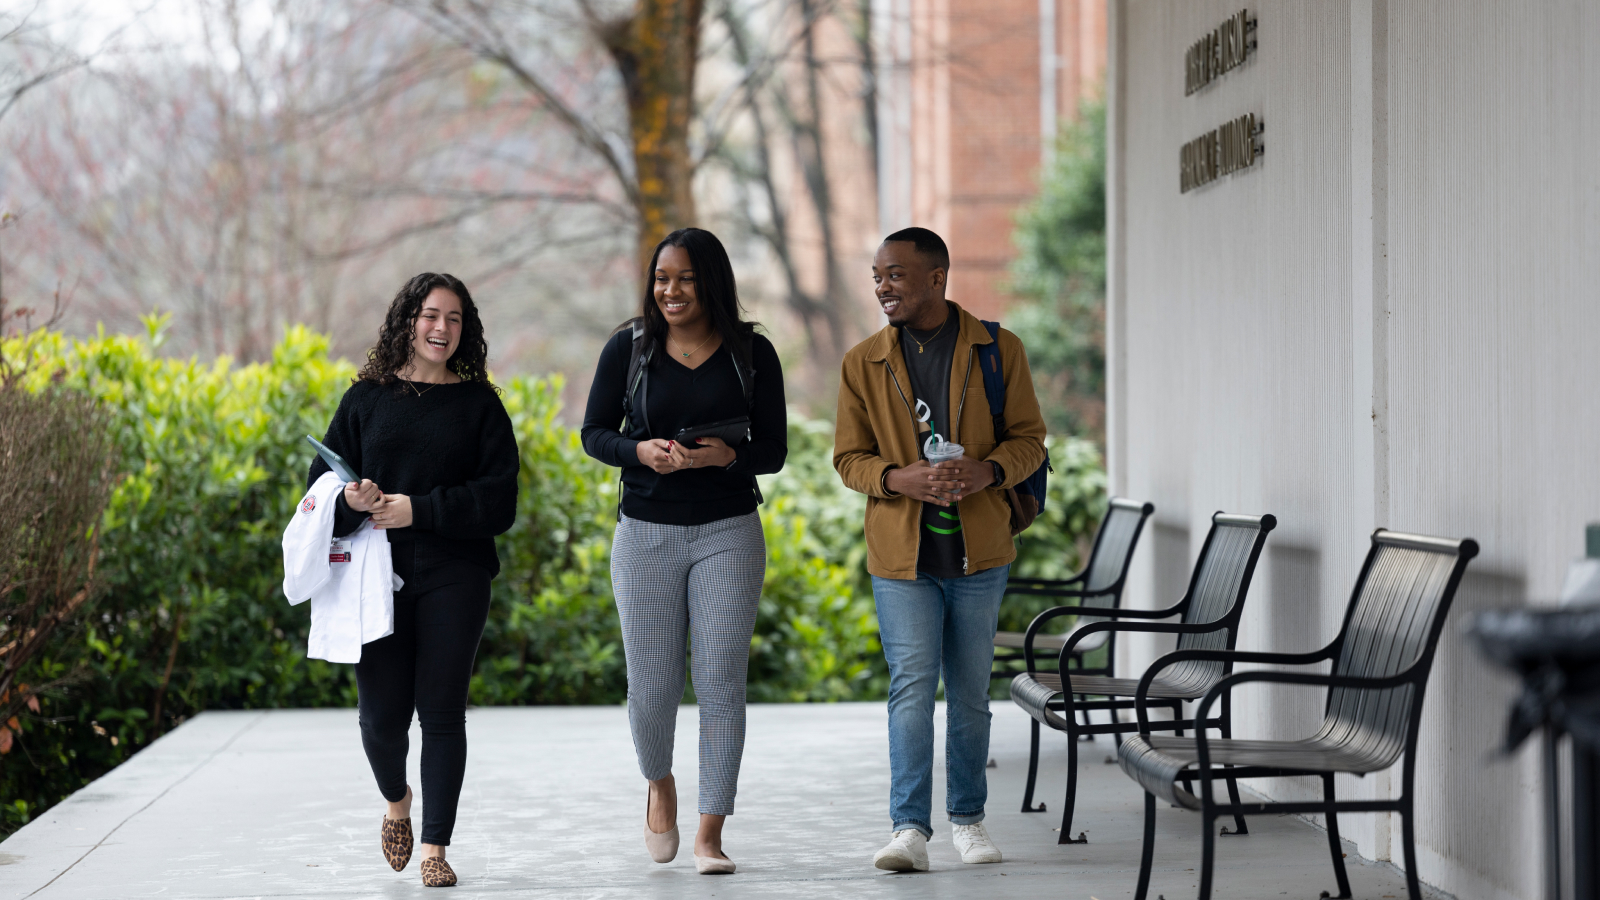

{"left": 989, "top": 496, "right": 1155, "bottom": 682}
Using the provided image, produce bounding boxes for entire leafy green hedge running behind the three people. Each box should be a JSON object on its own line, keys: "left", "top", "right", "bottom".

{"left": 0, "top": 317, "right": 1104, "bottom": 834}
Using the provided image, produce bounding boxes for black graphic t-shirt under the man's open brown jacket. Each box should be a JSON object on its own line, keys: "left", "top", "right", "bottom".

{"left": 901, "top": 309, "right": 966, "bottom": 578}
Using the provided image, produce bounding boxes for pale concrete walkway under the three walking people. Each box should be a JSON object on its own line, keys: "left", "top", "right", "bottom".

{"left": 0, "top": 701, "right": 1440, "bottom": 900}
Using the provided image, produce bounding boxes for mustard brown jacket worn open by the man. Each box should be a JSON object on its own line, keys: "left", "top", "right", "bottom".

{"left": 834, "top": 303, "right": 1045, "bottom": 580}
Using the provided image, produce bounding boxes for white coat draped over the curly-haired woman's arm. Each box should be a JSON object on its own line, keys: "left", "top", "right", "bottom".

{"left": 283, "top": 472, "right": 403, "bottom": 663}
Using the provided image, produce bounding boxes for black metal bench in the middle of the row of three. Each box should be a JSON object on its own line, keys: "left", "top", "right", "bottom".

{"left": 1011, "top": 512, "right": 1278, "bottom": 844}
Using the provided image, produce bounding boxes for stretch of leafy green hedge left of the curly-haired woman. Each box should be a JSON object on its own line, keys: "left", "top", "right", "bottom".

{"left": 0, "top": 317, "right": 354, "bottom": 830}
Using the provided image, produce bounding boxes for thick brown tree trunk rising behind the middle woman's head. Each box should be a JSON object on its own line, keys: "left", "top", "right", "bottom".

{"left": 600, "top": 0, "right": 704, "bottom": 271}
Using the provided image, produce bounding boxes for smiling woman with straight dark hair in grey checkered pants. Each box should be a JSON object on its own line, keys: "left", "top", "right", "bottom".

{"left": 584, "top": 227, "right": 789, "bottom": 874}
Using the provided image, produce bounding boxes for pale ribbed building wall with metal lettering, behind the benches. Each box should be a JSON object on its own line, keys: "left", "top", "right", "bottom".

{"left": 1109, "top": 0, "right": 1600, "bottom": 900}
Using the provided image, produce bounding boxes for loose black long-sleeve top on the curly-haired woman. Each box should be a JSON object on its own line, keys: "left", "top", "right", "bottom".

{"left": 306, "top": 381, "right": 520, "bottom": 577}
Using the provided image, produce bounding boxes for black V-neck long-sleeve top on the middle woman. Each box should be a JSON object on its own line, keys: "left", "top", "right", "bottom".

{"left": 584, "top": 330, "right": 789, "bottom": 525}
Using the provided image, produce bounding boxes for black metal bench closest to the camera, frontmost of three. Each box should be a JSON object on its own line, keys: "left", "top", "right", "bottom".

{"left": 1117, "top": 528, "right": 1478, "bottom": 900}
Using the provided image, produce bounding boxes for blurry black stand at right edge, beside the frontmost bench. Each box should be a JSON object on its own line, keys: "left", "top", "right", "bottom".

{"left": 1470, "top": 605, "right": 1600, "bottom": 900}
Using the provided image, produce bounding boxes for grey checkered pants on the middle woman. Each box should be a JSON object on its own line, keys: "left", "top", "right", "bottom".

{"left": 611, "top": 512, "right": 766, "bottom": 815}
